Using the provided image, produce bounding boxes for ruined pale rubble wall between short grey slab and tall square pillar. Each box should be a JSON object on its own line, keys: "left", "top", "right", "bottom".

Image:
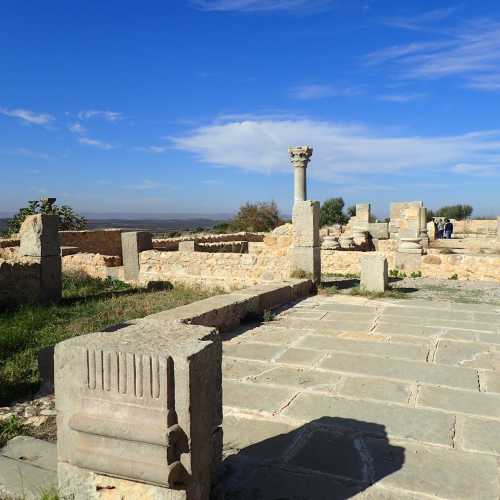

{"left": 139, "top": 234, "right": 291, "bottom": 290}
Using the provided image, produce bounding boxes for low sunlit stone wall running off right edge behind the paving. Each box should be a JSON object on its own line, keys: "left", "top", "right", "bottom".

{"left": 421, "top": 253, "right": 500, "bottom": 281}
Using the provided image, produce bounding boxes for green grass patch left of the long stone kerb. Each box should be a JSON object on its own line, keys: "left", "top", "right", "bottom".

{"left": 0, "top": 274, "right": 218, "bottom": 406}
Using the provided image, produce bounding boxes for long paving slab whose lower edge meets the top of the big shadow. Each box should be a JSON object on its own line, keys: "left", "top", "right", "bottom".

{"left": 283, "top": 393, "right": 455, "bottom": 446}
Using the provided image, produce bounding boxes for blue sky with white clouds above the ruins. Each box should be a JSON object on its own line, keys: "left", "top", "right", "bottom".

{"left": 0, "top": 0, "right": 500, "bottom": 216}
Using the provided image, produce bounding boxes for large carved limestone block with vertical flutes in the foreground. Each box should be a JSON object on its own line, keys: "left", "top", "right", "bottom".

{"left": 54, "top": 320, "right": 222, "bottom": 500}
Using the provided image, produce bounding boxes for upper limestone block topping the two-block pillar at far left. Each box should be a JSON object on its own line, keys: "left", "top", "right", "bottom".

{"left": 19, "top": 214, "right": 61, "bottom": 257}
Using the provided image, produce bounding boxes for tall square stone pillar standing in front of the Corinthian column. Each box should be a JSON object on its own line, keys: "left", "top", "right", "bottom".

{"left": 291, "top": 200, "right": 321, "bottom": 283}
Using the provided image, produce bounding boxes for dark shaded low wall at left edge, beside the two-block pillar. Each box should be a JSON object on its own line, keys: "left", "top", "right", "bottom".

{"left": 0, "top": 257, "right": 41, "bottom": 307}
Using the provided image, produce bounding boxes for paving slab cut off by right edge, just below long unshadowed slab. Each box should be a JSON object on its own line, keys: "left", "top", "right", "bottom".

{"left": 417, "top": 386, "right": 500, "bottom": 420}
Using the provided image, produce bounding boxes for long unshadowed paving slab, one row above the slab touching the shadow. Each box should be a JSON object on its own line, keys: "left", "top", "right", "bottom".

{"left": 319, "top": 352, "right": 478, "bottom": 390}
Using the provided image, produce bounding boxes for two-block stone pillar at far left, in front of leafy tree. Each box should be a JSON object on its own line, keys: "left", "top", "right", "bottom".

{"left": 19, "top": 214, "right": 62, "bottom": 303}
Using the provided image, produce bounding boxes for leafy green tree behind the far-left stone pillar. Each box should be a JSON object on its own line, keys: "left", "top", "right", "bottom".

{"left": 6, "top": 198, "right": 87, "bottom": 235}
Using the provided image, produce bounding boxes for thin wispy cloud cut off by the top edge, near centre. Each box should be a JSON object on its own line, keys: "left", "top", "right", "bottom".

{"left": 192, "top": 0, "right": 334, "bottom": 12}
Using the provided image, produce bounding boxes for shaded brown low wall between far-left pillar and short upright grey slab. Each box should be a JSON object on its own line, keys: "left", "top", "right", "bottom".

{"left": 59, "top": 229, "right": 124, "bottom": 257}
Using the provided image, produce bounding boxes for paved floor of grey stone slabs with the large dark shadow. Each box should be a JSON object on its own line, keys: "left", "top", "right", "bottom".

{"left": 220, "top": 296, "right": 500, "bottom": 500}
